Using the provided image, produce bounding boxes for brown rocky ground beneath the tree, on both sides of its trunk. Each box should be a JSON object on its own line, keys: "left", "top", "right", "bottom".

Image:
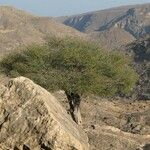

{"left": 53, "top": 91, "right": 150, "bottom": 150}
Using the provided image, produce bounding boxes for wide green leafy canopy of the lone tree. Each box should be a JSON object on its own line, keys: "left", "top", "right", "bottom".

{"left": 1, "top": 38, "right": 137, "bottom": 96}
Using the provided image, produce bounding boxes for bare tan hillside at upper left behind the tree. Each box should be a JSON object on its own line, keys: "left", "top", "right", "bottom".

{"left": 0, "top": 6, "right": 86, "bottom": 57}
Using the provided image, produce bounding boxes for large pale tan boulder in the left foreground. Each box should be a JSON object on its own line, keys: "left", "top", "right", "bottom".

{"left": 0, "top": 77, "right": 89, "bottom": 150}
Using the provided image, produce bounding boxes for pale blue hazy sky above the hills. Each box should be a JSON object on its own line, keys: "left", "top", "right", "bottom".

{"left": 0, "top": 0, "right": 150, "bottom": 16}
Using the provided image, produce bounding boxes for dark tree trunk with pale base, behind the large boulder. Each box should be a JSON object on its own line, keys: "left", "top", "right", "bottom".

{"left": 66, "top": 92, "right": 82, "bottom": 125}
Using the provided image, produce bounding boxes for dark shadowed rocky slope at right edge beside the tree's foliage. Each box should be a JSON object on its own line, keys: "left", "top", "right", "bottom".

{"left": 126, "top": 37, "right": 150, "bottom": 99}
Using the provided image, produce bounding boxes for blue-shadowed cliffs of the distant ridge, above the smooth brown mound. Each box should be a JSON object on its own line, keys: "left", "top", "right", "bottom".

{"left": 58, "top": 4, "right": 150, "bottom": 38}
